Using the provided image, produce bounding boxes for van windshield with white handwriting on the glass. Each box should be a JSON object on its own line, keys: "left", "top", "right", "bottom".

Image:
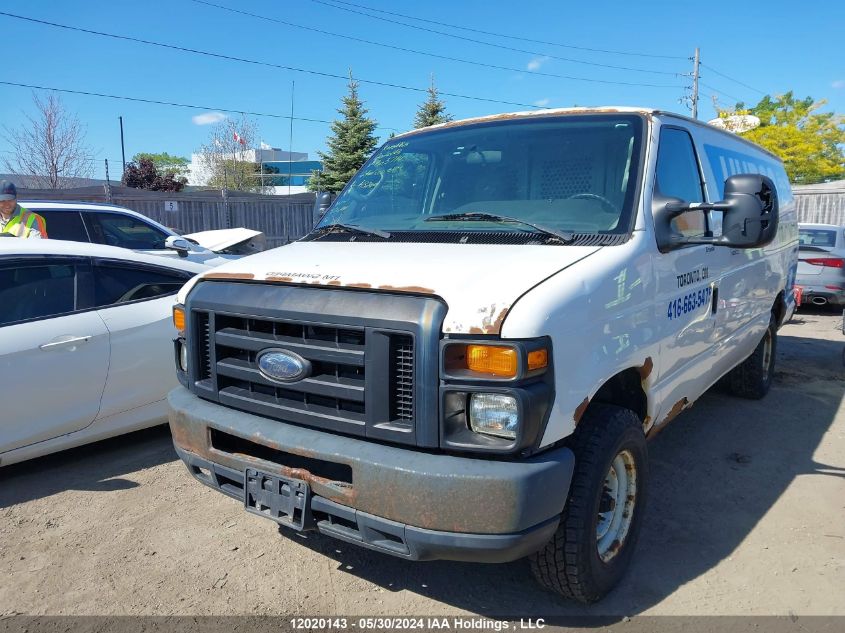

{"left": 314, "top": 115, "right": 644, "bottom": 244}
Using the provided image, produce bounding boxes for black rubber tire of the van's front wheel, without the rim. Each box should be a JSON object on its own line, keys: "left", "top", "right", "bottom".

{"left": 530, "top": 403, "right": 648, "bottom": 603}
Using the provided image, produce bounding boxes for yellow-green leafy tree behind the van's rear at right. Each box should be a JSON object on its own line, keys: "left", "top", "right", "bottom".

{"left": 719, "top": 91, "right": 845, "bottom": 184}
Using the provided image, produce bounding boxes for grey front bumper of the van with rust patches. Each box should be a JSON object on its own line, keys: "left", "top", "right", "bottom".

{"left": 168, "top": 387, "right": 575, "bottom": 562}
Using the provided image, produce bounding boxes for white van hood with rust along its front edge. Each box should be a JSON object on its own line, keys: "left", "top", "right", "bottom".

{"left": 179, "top": 242, "right": 600, "bottom": 334}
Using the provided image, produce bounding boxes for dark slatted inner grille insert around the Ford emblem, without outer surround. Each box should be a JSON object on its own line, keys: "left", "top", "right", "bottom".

{"left": 194, "top": 311, "right": 414, "bottom": 442}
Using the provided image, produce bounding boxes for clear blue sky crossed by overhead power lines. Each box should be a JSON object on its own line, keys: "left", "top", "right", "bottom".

{"left": 0, "top": 0, "right": 845, "bottom": 178}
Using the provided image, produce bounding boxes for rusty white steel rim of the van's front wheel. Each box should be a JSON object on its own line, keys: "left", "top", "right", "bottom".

{"left": 596, "top": 450, "right": 637, "bottom": 563}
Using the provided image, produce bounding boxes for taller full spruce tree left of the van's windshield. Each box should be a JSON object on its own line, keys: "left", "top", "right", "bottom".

{"left": 308, "top": 75, "right": 378, "bottom": 193}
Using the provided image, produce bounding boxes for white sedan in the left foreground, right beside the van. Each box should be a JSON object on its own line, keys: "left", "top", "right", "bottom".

{"left": 0, "top": 238, "right": 209, "bottom": 466}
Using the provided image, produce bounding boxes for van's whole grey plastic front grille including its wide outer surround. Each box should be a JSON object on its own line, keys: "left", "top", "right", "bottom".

{"left": 185, "top": 279, "right": 446, "bottom": 448}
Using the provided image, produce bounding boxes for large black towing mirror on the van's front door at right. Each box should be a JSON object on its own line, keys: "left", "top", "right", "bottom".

{"left": 652, "top": 174, "right": 779, "bottom": 252}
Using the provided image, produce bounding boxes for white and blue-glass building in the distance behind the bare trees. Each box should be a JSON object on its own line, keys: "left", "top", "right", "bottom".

{"left": 188, "top": 147, "right": 323, "bottom": 195}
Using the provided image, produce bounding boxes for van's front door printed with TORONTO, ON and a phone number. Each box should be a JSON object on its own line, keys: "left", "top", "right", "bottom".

{"left": 654, "top": 125, "right": 721, "bottom": 424}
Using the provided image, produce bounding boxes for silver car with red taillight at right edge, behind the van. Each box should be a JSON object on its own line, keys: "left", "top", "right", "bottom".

{"left": 795, "top": 223, "right": 845, "bottom": 306}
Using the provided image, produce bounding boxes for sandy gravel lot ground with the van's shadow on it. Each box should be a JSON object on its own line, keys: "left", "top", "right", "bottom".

{"left": 0, "top": 311, "right": 845, "bottom": 617}
